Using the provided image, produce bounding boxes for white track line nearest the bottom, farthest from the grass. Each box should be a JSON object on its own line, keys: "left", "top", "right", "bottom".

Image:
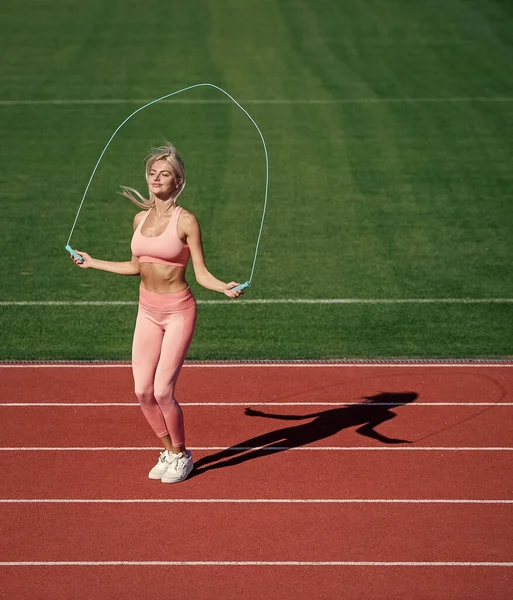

{"left": 0, "top": 560, "right": 513, "bottom": 567}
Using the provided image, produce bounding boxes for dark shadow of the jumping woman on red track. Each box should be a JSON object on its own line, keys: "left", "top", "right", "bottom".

{"left": 191, "top": 392, "right": 418, "bottom": 476}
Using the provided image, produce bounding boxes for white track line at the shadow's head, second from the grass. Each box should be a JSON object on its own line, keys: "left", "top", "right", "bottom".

{"left": 0, "top": 402, "right": 513, "bottom": 408}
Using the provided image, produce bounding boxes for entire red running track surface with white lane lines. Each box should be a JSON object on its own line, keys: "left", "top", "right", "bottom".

{"left": 0, "top": 364, "right": 513, "bottom": 600}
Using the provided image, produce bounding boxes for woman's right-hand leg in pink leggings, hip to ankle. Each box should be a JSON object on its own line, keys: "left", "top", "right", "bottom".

{"left": 154, "top": 305, "right": 196, "bottom": 454}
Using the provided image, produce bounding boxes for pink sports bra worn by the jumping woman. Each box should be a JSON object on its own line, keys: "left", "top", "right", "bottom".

{"left": 131, "top": 206, "right": 191, "bottom": 268}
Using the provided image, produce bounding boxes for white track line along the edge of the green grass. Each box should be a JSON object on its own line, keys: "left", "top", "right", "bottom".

{"left": 0, "top": 359, "right": 513, "bottom": 369}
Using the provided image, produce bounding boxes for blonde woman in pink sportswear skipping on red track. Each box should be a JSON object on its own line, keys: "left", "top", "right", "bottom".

{"left": 73, "top": 144, "right": 242, "bottom": 483}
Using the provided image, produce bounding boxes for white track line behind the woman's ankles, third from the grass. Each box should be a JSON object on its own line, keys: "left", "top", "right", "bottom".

{"left": 0, "top": 445, "right": 513, "bottom": 452}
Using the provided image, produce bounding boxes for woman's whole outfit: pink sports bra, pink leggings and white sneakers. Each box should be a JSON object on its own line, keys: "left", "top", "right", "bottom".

{"left": 131, "top": 206, "right": 196, "bottom": 481}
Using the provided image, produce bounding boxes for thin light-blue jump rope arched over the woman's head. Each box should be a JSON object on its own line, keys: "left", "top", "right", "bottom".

{"left": 65, "top": 83, "right": 269, "bottom": 291}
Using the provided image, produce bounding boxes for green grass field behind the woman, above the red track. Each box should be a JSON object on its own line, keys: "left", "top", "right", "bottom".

{"left": 0, "top": 0, "right": 513, "bottom": 360}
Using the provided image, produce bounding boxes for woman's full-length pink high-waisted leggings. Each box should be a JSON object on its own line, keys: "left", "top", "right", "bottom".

{"left": 132, "top": 286, "right": 196, "bottom": 447}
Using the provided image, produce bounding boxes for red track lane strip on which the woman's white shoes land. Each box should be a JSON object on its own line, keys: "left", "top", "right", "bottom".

{"left": 0, "top": 450, "right": 513, "bottom": 500}
